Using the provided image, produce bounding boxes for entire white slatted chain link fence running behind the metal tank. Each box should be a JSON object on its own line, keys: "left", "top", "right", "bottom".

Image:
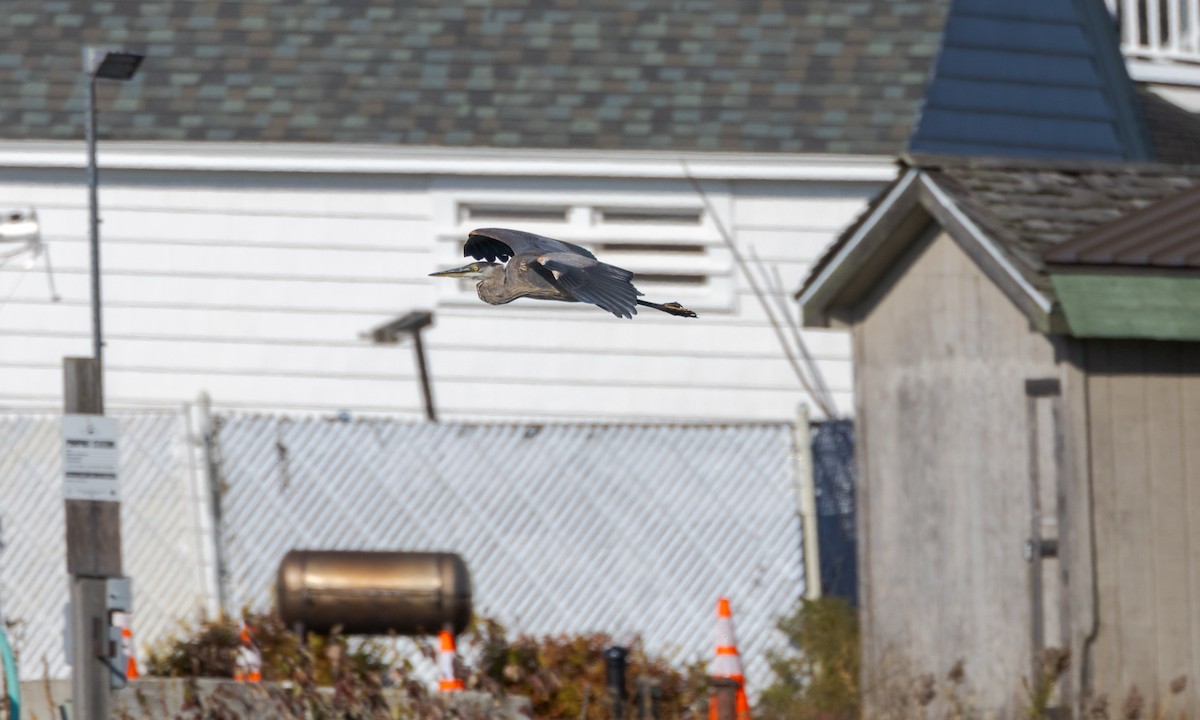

{"left": 0, "top": 410, "right": 824, "bottom": 686}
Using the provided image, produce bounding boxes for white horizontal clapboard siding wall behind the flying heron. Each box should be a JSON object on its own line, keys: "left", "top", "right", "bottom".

{"left": 0, "top": 145, "right": 892, "bottom": 420}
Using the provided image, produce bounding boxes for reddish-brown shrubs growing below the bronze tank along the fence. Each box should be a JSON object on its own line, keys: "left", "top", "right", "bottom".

{"left": 145, "top": 610, "right": 708, "bottom": 720}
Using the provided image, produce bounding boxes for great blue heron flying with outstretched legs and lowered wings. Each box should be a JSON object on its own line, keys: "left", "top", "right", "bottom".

{"left": 431, "top": 228, "right": 696, "bottom": 318}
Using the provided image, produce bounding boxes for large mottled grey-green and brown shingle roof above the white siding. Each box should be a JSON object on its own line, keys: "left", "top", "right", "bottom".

{"left": 0, "top": 0, "right": 948, "bottom": 155}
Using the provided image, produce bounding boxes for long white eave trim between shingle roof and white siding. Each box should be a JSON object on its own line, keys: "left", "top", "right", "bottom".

{"left": 0, "top": 140, "right": 895, "bottom": 182}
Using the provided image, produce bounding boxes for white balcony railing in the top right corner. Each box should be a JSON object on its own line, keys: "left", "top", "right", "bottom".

{"left": 1105, "top": 0, "right": 1200, "bottom": 79}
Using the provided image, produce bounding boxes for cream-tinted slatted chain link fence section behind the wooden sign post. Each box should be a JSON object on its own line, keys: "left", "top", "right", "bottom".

{"left": 0, "top": 412, "right": 212, "bottom": 679}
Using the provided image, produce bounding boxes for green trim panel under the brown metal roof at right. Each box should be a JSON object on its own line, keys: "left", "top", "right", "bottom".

{"left": 1050, "top": 270, "right": 1200, "bottom": 341}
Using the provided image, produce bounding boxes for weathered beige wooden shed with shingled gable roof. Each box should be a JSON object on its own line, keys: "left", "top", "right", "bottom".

{"left": 799, "top": 157, "right": 1200, "bottom": 716}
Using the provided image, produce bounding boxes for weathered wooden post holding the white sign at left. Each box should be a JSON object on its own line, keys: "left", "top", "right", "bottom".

{"left": 62, "top": 358, "right": 121, "bottom": 720}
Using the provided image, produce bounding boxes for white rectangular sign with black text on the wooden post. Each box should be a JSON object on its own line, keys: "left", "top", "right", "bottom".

{"left": 62, "top": 415, "right": 121, "bottom": 503}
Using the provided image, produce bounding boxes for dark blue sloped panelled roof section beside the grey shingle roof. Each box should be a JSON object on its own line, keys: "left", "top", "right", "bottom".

{"left": 910, "top": 0, "right": 1152, "bottom": 161}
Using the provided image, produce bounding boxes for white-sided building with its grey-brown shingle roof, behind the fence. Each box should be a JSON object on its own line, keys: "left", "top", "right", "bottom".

{"left": 0, "top": 0, "right": 942, "bottom": 421}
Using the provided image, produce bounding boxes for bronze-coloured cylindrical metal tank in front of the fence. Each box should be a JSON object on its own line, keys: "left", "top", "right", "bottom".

{"left": 277, "top": 550, "right": 470, "bottom": 635}
